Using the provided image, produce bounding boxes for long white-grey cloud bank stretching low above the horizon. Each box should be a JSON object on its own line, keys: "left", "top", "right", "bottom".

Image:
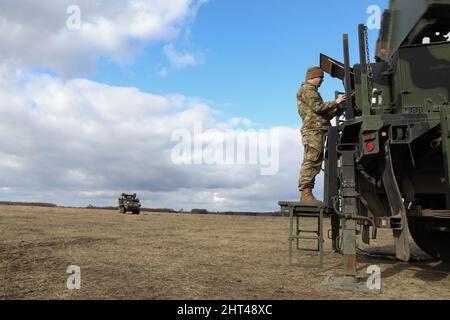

{"left": 0, "top": 68, "right": 301, "bottom": 211}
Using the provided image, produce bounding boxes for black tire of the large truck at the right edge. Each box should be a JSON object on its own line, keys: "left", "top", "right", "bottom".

{"left": 408, "top": 218, "right": 450, "bottom": 262}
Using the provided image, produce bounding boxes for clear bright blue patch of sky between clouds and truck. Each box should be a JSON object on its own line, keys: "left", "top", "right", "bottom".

{"left": 89, "top": 0, "right": 388, "bottom": 127}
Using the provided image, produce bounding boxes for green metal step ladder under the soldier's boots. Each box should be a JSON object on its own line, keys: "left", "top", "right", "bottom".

{"left": 278, "top": 201, "right": 327, "bottom": 269}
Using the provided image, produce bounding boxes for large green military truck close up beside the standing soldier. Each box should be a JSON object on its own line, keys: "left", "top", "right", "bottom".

{"left": 280, "top": 0, "right": 450, "bottom": 288}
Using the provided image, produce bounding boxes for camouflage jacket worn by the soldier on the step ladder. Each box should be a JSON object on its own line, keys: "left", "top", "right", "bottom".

{"left": 297, "top": 83, "right": 338, "bottom": 135}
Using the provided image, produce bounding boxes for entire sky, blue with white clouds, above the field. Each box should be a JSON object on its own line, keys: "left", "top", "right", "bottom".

{"left": 0, "top": 0, "right": 388, "bottom": 211}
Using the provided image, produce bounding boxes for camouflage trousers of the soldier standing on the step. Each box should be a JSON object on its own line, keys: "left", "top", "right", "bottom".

{"left": 298, "top": 130, "right": 326, "bottom": 192}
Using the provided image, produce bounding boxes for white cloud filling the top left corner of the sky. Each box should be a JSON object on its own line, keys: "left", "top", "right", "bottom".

{"left": 0, "top": 0, "right": 206, "bottom": 77}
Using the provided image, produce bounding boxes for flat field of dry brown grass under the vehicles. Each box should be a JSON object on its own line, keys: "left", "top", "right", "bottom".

{"left": 0, "top": 206, "right": 450, "bottom": 300}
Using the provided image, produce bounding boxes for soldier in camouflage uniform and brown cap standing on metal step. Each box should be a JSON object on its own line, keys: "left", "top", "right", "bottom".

{"left": 297, "top": 67, "right": 347, "bottom": 205}
